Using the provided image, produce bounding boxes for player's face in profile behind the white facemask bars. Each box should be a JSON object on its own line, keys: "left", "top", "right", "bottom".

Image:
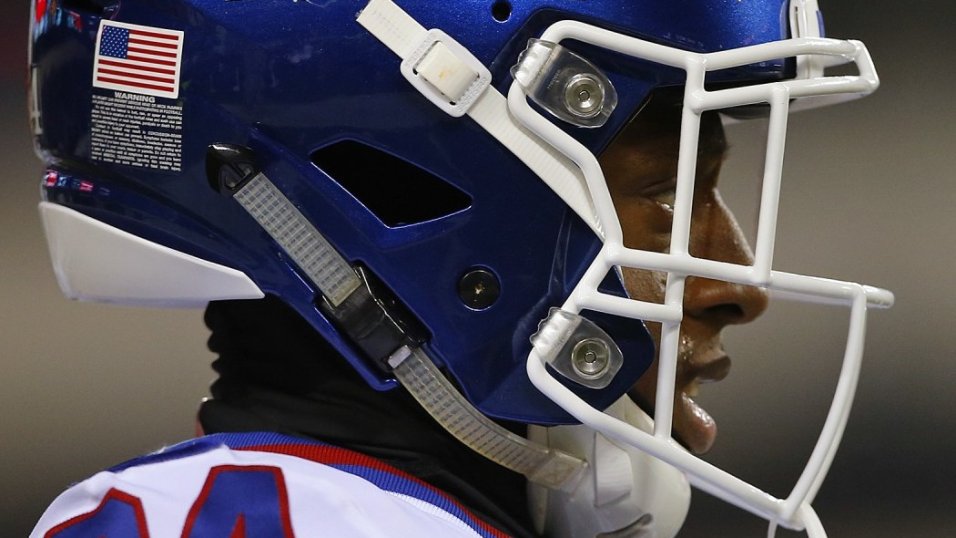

{"left": 600, "top": 96, "right": 767, "bottom": 454}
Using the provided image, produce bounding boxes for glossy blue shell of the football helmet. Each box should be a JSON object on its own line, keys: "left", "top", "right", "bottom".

{"left": 31, "top": 0, "right": 792, "bottom": 424}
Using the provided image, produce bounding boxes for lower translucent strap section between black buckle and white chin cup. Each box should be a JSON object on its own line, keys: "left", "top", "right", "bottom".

{"left": 388, "top": 346, "right": 587, "bottom": 492}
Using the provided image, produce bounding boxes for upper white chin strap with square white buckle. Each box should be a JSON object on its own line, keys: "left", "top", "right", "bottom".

{"left": 358, "top": 0, "right": 603, "bottom": 235}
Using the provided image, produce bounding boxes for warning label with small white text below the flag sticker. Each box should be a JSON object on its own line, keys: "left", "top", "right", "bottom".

{"left": 90, "top": 91, "right": 183, "bottom": 172}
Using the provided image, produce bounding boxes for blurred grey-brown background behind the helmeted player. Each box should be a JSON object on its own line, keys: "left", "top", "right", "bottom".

{"left": 0, "top": 0, "right": 956, "bottom": 538}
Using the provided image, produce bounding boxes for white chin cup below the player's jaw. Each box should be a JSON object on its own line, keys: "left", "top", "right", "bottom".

{"left": 528, "top": 396, "right": 690, "bottom": 538}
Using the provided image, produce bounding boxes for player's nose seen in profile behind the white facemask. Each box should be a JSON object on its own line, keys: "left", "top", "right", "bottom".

{"left": 684, "top": 190, "right": 769, "bottom": 326}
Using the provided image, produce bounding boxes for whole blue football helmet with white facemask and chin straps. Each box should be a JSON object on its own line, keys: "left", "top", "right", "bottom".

{"left": 30, "top": 0, "right": 893, "bottom": 536}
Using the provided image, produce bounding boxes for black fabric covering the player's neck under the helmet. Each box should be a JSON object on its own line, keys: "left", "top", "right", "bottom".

{"left": 199, "top": 297, "right": 535, "bottom": 538}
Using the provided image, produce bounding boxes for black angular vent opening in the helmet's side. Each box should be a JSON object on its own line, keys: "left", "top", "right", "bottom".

{"left": 312, "top": 140, "right": 471, "bottom": 228}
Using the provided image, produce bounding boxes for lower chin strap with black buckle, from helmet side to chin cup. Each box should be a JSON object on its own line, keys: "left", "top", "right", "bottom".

{"left": 214, "top": 159, "right": 587, "bottom": 491}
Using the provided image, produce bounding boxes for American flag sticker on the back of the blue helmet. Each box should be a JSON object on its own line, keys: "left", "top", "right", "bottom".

{"left": 93, "top": 21, "right": 183, "bottom": 99}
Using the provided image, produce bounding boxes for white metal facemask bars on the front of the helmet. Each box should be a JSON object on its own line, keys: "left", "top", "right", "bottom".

{"left": 508, "top": 21, "right": 893, "bottom": 537}
